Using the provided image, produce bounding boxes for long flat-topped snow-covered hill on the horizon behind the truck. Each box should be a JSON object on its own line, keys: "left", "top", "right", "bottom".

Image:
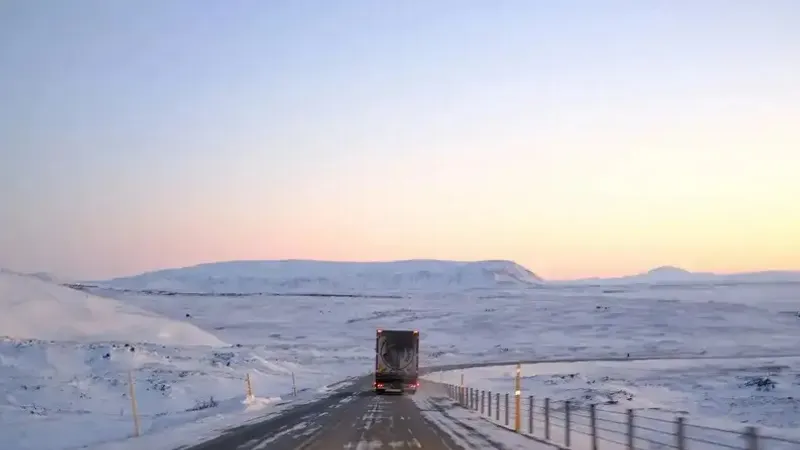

{"left": 98, "top": 260, "right": 542, "bottom": 294}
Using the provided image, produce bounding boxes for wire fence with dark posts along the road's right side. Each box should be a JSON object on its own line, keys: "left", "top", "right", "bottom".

{"left": 426, "top": 380, "right": 800, "bottom": 450}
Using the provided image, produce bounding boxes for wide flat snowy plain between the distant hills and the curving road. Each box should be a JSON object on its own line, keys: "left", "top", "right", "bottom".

{"left": 83, "top": 285, "right": 800, "bottom": 364}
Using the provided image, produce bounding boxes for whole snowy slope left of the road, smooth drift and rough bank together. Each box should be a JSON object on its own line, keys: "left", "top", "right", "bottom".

{"left": 0, "top": 270, "right": 348, "bottom": 450}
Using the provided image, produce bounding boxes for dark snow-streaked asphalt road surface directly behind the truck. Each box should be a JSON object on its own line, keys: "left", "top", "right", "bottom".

{"left": 184, "top": 376, "right": 462, "bottom": 450}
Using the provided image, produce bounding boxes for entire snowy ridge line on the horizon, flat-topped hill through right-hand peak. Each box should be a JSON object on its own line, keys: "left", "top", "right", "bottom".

{"left": 87, "top": 260, "right": 800, "bottom": 298}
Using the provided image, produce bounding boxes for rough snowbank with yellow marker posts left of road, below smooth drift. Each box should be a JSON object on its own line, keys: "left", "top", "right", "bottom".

{"left": 0, "top": 339, "right": 354, "bottom": 450}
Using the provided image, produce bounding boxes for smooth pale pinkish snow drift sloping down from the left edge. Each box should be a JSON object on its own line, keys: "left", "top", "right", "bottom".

{"left": 0, "top": 271, "right": 227, "bottom": 346}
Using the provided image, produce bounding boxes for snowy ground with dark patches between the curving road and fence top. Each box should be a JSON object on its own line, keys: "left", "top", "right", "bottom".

{"left": 428, "top": 357, "right": 800, "bottom": 449}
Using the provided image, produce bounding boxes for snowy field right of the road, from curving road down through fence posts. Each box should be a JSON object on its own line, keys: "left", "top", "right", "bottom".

{"left": 426, "top": 357, "right": 800, "bottom": 450}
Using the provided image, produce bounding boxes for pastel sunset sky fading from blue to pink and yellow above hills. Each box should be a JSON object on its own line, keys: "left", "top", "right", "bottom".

{"left": 0, "top": 0, "right": 800, "bottom": 279}
